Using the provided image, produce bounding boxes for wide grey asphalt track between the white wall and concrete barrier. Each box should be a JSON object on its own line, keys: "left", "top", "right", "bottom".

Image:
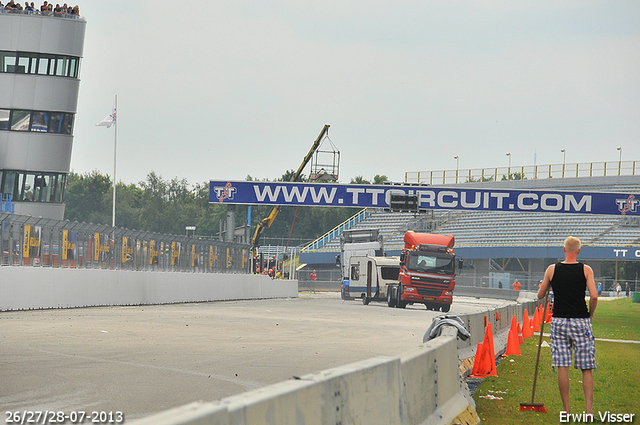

{"left": 0, "top": 293, "right": 512, "bottom": 423}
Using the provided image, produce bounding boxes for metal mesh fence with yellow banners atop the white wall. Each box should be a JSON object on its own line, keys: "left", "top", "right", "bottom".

{"left": 0, "top": 213, "right": 250, "bottom": 273}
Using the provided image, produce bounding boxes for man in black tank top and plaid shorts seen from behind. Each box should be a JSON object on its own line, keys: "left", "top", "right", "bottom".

{"left": 538, "top": 236, "right": 598, "bottom": 418}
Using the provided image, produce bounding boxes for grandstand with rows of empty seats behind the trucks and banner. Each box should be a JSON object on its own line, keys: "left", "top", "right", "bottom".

{"left": 300, "top": 175, "right": 640, "bottom": 288}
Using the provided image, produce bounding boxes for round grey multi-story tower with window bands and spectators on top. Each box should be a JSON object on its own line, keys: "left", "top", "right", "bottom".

{"left": 0, "top": 8, "right": 86, "bottom": 220}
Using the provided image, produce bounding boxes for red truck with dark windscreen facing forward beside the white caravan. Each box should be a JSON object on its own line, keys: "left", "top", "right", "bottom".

{"left": 387, "top": 231, "right": 462, "bottom": 313}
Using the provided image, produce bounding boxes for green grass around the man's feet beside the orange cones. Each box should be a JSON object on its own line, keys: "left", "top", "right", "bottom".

{"left": 473, "top": 299, "right": 640, "bottom": 424}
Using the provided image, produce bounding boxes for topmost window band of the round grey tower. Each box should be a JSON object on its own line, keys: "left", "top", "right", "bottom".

{"left": 0, "top": 51, "right": 80, "bottom": 78}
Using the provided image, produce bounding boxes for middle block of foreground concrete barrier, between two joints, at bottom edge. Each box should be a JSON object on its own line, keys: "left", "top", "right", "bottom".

{"left": 221, "top": 358, "right": 401, "bottom": 425}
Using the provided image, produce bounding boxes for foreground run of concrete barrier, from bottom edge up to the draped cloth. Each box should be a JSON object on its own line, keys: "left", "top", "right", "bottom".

{"left": 132, "top": 330, "right": 480, "bottom": 425}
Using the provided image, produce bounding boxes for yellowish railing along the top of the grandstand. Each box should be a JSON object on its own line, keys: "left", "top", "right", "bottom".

{"left": 404, "top": 161, "right": 640, "bottom": 185}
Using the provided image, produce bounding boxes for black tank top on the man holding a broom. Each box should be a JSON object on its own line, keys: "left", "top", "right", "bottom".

{"left": 551, "top": 263, "right": 589, "bottom": 318}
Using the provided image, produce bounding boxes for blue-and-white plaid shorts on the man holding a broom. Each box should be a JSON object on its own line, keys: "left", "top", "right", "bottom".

{"left": 551, "top": 317, "right": 596, "bottom": 369}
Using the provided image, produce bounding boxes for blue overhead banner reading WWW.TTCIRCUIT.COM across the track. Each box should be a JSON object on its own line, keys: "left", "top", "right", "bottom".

{"left": 209, "top": 181, "right": 640, "bottom": 216}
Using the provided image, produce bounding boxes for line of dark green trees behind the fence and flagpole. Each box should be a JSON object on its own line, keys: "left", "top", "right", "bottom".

{"left": 65, "top": 170, "right": 387, "bottom": 246}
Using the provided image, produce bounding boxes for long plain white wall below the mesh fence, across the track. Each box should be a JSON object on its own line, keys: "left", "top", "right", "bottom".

{"left": 0, "top": 267, "right": 298, "bottom": 311}
